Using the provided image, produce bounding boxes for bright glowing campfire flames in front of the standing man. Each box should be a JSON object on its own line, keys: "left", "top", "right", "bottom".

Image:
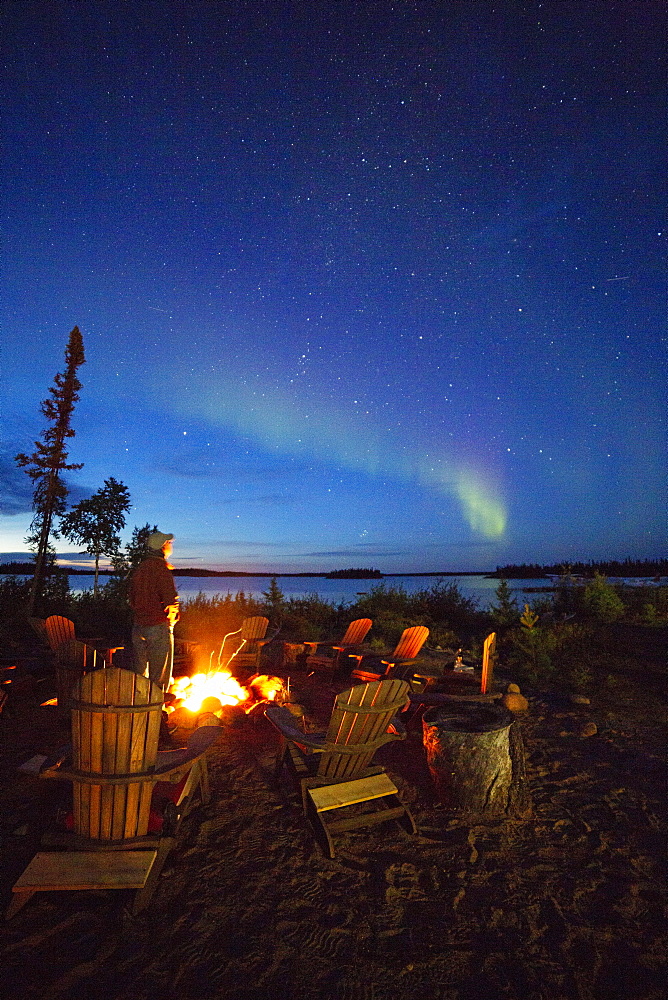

{"left": 165, "top": 669, "right": 288, "bottom": 729}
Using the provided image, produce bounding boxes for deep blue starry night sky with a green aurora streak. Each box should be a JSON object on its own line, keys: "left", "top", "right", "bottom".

{"left": 0, "top": 0, "right": 666, "bottom": 573}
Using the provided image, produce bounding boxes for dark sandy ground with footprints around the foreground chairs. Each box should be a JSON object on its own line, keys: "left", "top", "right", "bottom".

{"left": 0, "top": 634, "right": 666, "bottom": 1000}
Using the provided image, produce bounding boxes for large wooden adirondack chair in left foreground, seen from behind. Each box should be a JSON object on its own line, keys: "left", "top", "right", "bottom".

{"left": 7, "top": 667, "right": 220, "bottom": 918}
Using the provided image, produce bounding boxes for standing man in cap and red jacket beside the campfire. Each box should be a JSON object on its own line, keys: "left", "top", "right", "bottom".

{"left": 129, "top": 531, "right": 179, "bottom": 690}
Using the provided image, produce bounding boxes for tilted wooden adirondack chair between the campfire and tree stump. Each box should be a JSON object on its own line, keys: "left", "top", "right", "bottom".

{"left": 266, "top": 680, "right": 417, "bottom": 858}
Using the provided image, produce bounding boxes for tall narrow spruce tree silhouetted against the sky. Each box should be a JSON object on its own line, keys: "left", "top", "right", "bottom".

{"left": 15, "top": 326, "right": 86, "bottom": 613}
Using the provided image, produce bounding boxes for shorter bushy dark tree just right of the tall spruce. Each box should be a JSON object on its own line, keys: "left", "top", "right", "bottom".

{"left": 60, "top": 476, "right": 131, "bottom": 596}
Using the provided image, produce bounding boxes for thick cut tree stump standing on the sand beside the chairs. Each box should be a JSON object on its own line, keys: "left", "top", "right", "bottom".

{"left": 422, "top": 702, "right": 531, "bottom": 818}
